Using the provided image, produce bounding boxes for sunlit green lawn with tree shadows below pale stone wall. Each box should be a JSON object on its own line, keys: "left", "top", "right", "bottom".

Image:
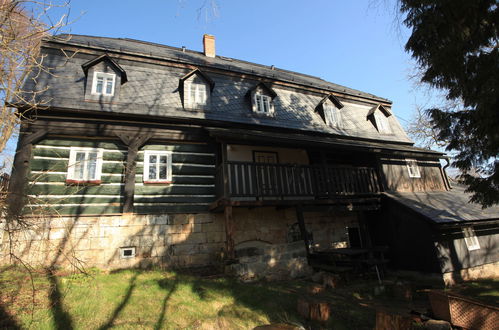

{"left": 0, "top": 269, "right": 310, "bottom": 329}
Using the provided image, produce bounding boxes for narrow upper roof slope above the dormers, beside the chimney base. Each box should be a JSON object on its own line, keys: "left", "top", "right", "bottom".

{"left": 52, "top": 34, "right": 391, "bottom": 103}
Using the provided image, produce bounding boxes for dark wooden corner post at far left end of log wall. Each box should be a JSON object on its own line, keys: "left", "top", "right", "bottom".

{"left": 7, "top": 130, "right": 48, "bottom": 218}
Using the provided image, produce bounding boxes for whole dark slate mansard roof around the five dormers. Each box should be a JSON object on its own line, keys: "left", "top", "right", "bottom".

{"left": 25, "top": 35, "right": 413, "bottom": 145}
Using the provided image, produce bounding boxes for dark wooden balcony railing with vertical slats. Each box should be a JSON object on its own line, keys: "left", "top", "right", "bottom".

{"left": 217, "top": 161, "right": 380, "bottom": 199}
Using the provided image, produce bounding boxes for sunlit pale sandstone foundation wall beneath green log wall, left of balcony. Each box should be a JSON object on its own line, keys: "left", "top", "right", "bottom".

{"left": 0, "top": 214, "right": 225, "bottom": 269}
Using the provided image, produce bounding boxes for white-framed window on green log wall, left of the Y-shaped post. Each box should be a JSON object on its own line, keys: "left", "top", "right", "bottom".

{"left": 66, "top": 147, "right": 102, "bottom": 183}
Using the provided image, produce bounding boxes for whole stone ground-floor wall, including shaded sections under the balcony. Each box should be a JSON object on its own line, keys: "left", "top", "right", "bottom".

{"left": 0, "top": 207, "right": 357, "bottom": 275}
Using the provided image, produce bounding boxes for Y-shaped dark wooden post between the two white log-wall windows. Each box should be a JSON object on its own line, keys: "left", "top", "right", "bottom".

{"left": 117, "top": 133, "right": 152, "bottom": 213}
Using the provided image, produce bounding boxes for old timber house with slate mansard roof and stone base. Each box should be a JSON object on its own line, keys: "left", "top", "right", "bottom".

{"left": 4, "top": 35, "right": 499, "bottom": 277}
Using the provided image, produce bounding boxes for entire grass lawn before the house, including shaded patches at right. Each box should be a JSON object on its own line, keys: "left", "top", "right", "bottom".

{"left": 0, "top": 268, "right": 499, "bottom": 330}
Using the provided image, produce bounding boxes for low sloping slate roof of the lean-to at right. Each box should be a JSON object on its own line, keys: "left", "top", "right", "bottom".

{"left": 385, "top": 185, "right": 499, "bottom": 224}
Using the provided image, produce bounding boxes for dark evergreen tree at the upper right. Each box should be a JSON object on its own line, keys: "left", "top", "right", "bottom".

{"left": 400, "top": 0, "right": 499, "bottom": 207}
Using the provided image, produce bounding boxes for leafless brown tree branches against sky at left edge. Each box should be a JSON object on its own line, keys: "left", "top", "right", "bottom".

{"left": 0, "top": 0, "right": 69, "bottom": 152}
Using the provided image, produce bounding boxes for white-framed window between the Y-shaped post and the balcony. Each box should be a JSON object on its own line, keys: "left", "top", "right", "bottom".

{"left": 144, "top": 150, "right": 172, "bottom": 183}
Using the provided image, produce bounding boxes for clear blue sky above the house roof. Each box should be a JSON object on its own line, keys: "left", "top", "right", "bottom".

{"left": 0, "top": 0, "right": 438, "bottom": 173}
